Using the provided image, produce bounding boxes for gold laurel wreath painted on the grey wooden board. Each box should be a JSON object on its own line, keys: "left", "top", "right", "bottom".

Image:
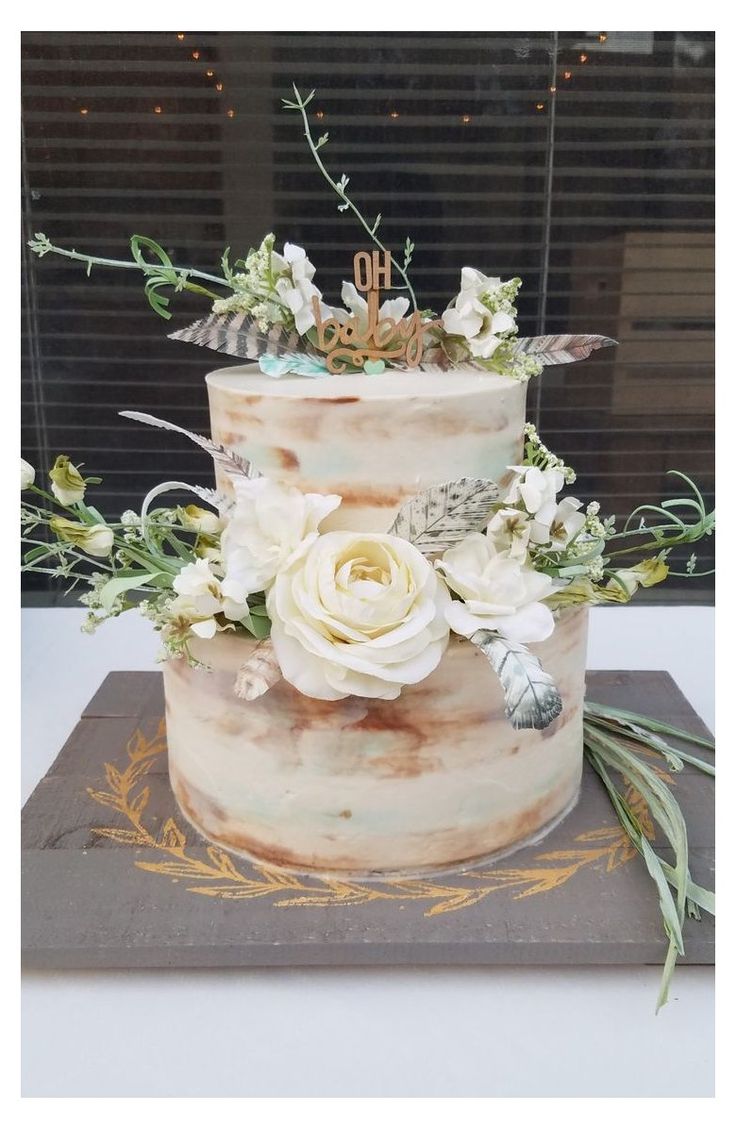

{"left": 87, "top": 719, "right": 669, "bottom": 917}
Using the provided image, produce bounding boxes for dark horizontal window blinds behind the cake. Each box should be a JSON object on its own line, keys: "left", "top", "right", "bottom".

{"left": 23, "top": 30, "right": 715, "bottom": 601}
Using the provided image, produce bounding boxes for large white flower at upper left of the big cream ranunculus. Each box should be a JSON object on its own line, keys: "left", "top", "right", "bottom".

{"left": 220, "top": 479, "right": 342, "bottom": 599}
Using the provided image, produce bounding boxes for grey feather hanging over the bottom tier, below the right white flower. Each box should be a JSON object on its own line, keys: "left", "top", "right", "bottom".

{"left": 471, "top": 629, "right": 562, "bottom": 729}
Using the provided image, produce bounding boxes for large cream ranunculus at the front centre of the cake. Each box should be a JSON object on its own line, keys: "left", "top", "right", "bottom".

{"left": 266, "top": 532, "right": 450, "bottom": 701}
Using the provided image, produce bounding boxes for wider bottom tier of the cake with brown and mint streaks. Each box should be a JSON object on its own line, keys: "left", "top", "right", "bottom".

{"left": 164, "top": 610, "right": 587, "bottom": 875}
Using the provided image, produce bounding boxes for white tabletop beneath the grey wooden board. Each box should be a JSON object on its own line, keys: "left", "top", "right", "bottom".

{"left": 21, "top": 606, "right": 715, "bottom": 1097}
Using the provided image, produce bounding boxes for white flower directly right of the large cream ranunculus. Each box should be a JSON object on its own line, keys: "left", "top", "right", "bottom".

{"left": 436, "top": 533, "right": 554, "bottom": 642}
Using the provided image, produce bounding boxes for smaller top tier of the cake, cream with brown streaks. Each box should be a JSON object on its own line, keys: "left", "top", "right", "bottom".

{"left": 207, "top": 365, "right": 526, "bottom": 533}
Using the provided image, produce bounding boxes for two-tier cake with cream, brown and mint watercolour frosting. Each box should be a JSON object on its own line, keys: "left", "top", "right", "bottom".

{"left": 164, "top": 365, "right": 587, "bottom": 872}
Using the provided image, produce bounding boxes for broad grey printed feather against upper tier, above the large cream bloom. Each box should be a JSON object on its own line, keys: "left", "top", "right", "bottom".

{"left": 388, "top": 479, "right": 499, "bottom": 554}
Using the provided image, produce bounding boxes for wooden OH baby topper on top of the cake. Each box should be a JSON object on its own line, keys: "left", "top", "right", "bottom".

{"left": 312, "top": 251, "right": 439, "bottom": 373}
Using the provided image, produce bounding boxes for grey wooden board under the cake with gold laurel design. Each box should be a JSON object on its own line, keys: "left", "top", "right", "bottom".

{"left": 23, "top": 671, "right": 715, "bottom": 969}
